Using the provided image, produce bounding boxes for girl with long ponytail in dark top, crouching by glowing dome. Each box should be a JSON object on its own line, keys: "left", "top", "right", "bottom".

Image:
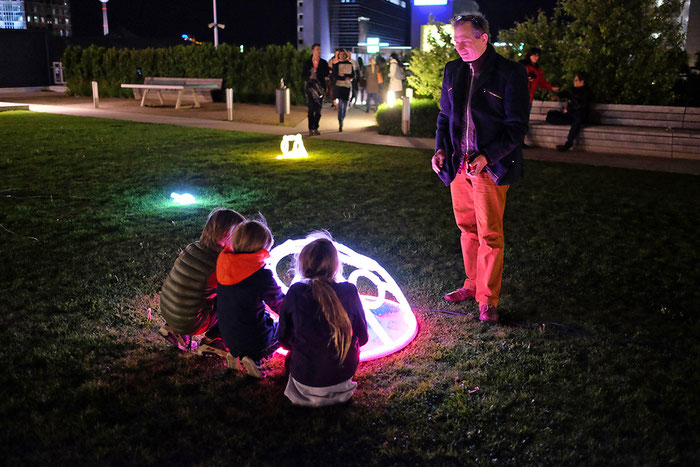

{"left": 279, "top": 234, "right": 368, "bottom": 407}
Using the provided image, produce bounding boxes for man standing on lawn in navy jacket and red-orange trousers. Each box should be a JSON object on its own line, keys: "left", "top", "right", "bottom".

{"left": 432, "top": 15, "right": 530, "bottom": 323}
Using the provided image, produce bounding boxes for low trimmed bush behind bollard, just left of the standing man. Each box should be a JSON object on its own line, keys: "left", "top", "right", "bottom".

{"left": 375, "top": 99, "right": 440, "bottom": 138}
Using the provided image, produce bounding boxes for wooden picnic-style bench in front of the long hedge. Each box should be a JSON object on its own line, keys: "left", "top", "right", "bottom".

{"left": 122, "top": 76, "right": 223, "bottom": 109}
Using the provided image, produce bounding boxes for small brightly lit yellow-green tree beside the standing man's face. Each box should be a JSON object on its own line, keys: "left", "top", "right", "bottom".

{"left": 407, "top": 16, "right": 459, "bottom": 100}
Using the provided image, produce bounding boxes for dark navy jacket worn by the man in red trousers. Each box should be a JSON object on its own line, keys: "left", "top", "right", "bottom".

{"left": 435, "top": 44, "right": 530, "bottom": 185}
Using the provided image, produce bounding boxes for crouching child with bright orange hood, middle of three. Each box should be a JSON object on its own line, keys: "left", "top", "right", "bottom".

{"left": 216, "top": 220, "right": 284, "bottom": 378}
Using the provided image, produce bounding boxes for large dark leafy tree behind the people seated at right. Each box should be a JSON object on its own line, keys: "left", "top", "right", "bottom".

{"left": 499, "top": 0, "right": 688, "bottom": 105}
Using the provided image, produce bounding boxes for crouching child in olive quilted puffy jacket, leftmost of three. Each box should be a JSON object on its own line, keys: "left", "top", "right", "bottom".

{"left": 158, "top": 208, "right": 245, "bottom": 358}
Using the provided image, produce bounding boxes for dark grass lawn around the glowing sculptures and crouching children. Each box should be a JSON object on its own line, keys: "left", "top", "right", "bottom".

{"left": 0, "top": 112, "right": 700, "bottom": 465}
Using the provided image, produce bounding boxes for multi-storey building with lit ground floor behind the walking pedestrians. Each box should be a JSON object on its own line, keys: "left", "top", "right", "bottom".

{"left": 297, "top": 0, "right": 411, "bottom": 57}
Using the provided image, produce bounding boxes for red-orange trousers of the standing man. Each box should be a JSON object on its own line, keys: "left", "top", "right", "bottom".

{"left": 450, "top": 171, "right": 508, "bottom": 306}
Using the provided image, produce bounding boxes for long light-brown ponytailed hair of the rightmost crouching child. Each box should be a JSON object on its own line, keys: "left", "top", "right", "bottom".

{"left": 297, "top": 232, "right": 352, "bottom": 365}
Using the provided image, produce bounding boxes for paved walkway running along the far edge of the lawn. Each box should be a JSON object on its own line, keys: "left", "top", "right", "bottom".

{"left": 0, "top": 89, "right": 700, "bottom": 175}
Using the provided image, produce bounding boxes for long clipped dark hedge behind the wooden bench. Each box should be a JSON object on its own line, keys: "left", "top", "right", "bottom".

{"left": 62, "top": 44, "right": 311, "bottom": 105}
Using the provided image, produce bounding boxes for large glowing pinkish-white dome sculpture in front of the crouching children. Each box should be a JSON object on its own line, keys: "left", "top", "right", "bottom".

{"left": 267, "top": 237, "right": 418, "bottom": 361}
